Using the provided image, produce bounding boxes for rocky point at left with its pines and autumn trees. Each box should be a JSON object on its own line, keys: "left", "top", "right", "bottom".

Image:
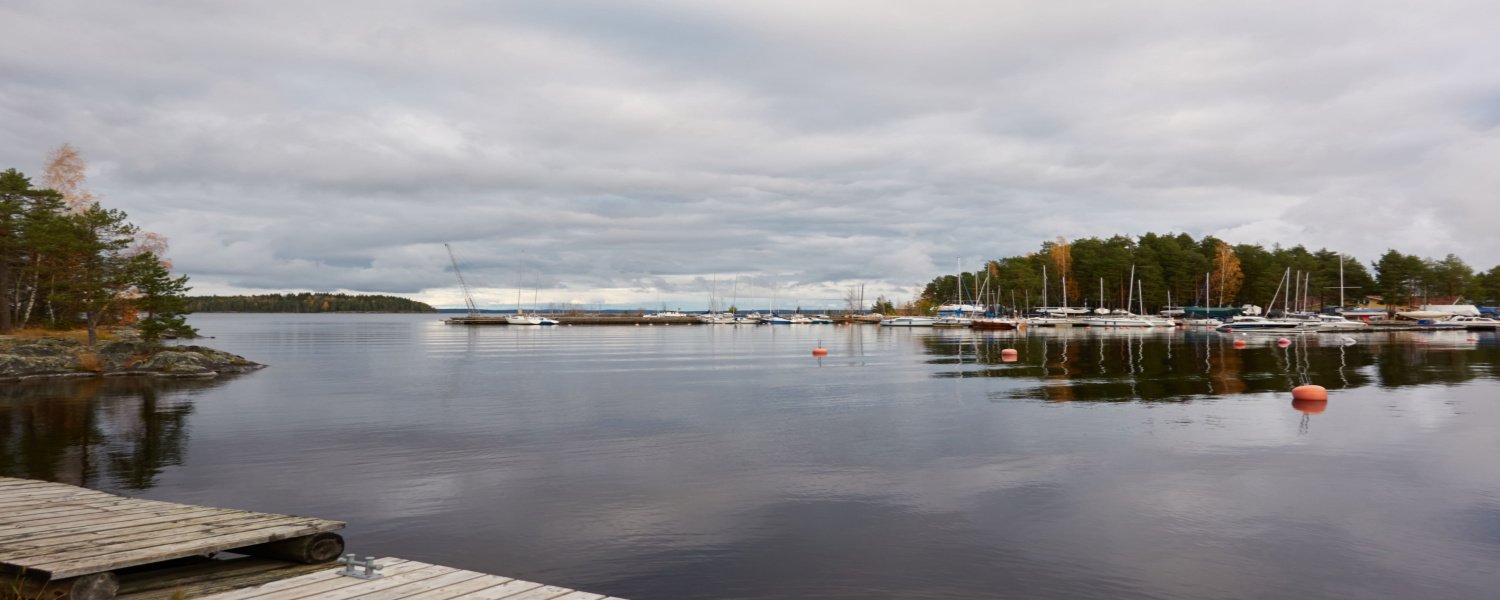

{"left": 0, "top": 144, "right": 261, "bottom": 381}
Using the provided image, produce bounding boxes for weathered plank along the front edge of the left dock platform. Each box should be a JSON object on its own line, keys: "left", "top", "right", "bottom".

{"left": 30, "top": 519, "right": 344, "bottom": 578}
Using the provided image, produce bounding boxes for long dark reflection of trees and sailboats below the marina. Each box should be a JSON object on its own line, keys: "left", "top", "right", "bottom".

{"left": 923, "top": 330, "right": 1500, "bottom": 402}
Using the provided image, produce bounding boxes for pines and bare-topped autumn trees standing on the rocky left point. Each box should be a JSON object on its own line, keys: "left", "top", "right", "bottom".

{"left": 0, "top": 144, "right": 197, "bottom": 345}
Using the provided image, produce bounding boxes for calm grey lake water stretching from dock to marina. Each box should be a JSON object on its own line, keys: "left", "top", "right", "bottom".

{"left": 0, "top": 315, "right": 1500, "bottom": 600}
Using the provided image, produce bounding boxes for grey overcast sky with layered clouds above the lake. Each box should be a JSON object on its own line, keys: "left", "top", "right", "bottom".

{"left": 0, "top": 0, "right": 1500, "bottom": 308}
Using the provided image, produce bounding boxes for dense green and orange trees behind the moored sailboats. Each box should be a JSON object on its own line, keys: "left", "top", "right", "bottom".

{"left": 909, "top": 233, "right": 1500, "bottom": 312}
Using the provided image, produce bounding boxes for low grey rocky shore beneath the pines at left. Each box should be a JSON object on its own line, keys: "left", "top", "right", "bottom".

{"left": 0, "top": 330, "right": 264, "bottom": 381}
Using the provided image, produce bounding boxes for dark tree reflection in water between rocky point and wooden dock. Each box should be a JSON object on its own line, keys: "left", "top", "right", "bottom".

{"left": 0, "top": 378, "right": 227, "bottom": 491}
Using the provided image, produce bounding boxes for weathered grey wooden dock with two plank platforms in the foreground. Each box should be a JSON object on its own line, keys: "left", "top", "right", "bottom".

{"left": 0, "top": 477, "right": 618, "bottom": 600}
